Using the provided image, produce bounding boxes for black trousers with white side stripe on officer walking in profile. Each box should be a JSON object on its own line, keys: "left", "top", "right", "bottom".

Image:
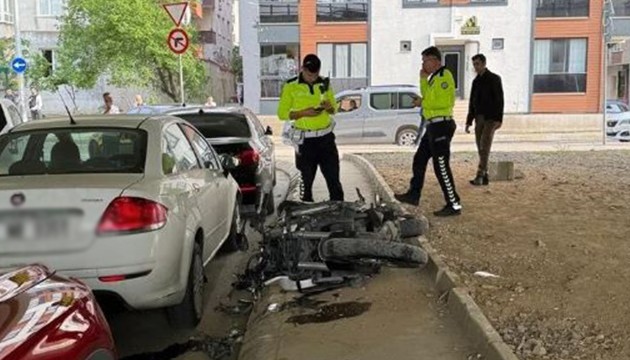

{"left": 409, "top": 120, "right": 460, "bottom": 209}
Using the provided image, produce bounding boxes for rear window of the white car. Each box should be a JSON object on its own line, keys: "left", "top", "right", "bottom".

{"left": 0, "top": 128, "right": 146, "bottom": 176}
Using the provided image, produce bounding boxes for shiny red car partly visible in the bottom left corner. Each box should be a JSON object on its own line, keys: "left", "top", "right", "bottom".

{"left": 0, "top": 265, "right": 117, "bottom": 360}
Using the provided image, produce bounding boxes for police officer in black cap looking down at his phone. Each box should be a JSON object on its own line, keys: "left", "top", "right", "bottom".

{"left": 278, "top": 54, "right": 343, "bottom": 202}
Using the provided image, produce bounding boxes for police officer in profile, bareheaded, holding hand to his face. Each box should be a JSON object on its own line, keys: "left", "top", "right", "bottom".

{"left": 395, "top": 46, "right": 462, "bottom": 216}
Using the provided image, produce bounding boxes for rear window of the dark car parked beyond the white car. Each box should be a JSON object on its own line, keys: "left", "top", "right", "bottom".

{"left": 176, "top": 113, "right": 252, "bottom": 139}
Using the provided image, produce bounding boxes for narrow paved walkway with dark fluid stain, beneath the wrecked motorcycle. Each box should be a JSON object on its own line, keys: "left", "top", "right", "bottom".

{"left": 239, "top": 161, "right": 475, "bottom": 360}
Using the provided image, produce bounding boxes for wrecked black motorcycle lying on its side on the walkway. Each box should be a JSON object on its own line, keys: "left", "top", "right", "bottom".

{"left": 233, "top": 190, "right": 427, "bottom": 294}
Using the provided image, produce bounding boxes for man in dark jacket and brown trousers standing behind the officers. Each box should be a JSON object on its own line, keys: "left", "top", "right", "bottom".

{"left": 466, "top": 54, "right": 504, "bottom": 186}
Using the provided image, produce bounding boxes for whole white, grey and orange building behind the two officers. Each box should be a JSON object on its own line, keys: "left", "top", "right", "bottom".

{"left": 241, "top": 0, "right": 604, "bottom": 114}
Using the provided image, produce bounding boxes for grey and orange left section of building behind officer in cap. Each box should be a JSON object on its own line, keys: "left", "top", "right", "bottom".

{"left": 240, "top": 0, "right": 369, "bottom": 114}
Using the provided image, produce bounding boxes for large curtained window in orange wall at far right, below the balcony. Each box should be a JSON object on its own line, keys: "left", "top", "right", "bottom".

{"left": 534, "top": 39, "right": 587, "bottom": 93}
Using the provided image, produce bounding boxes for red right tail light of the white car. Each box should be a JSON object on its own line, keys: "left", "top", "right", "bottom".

{"left": 96, "top": 196, "right": 167, "bottom": 235}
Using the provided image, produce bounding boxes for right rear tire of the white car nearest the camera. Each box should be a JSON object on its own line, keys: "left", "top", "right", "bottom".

{"left": 167, "top": 242, "right": 205, "bottom": 329}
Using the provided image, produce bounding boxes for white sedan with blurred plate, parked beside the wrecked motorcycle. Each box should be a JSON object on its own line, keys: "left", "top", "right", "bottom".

{"left": 0, "top": 115, "right": 244, "bottom": 327}
